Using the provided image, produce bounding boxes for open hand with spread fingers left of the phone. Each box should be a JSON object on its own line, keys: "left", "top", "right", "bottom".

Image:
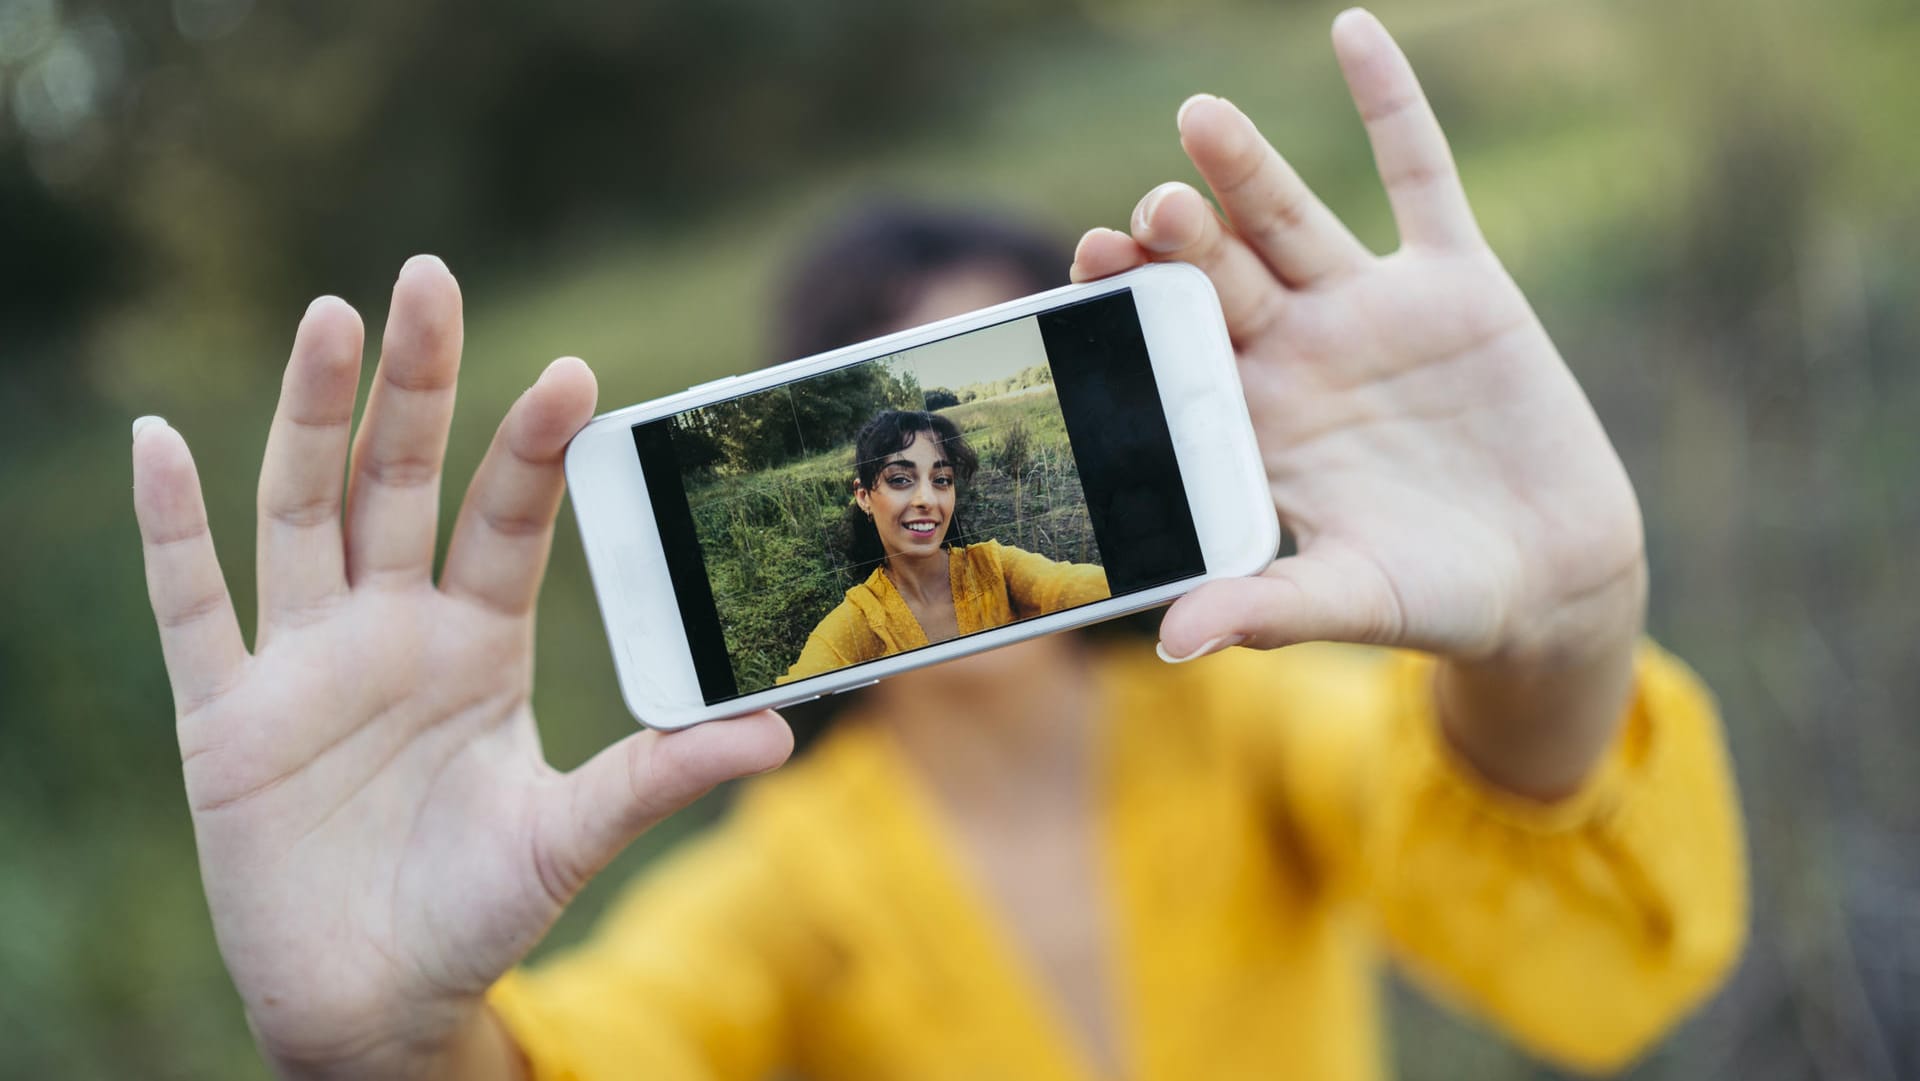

{"left": 132, "top": 257, "right": 791, "bottom": 1077}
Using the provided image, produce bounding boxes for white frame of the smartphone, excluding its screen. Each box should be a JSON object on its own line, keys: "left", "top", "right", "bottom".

{"left": 566, "top": 263, "right": 1281, "bottom": 730}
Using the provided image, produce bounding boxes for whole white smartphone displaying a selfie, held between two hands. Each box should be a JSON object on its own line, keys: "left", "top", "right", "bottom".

{"left": 566, "top": 263, "right": 1281, "bottom": 728}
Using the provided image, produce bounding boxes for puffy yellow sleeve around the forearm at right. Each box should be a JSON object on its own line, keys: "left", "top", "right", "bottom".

{"left": 1236, "top": 643, "right": 1747, "bottom": 1071}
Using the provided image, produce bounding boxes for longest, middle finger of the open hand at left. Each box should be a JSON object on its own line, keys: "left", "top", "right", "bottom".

{"left": 346, "top": 255, "right": 461, "bottom": 584}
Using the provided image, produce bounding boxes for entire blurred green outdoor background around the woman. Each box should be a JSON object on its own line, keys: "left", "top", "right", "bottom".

{"left": 0, "top": 0, "right": 1920, "bottom": 1079}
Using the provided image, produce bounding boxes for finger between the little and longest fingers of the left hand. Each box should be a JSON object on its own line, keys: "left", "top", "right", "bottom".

{"left": 257, "top": 296, "right": 365, "bottom": 633}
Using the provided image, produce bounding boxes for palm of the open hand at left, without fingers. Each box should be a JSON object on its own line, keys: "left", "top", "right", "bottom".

{"left": 182, "top": 589, "right": 564, "bottom": 1046}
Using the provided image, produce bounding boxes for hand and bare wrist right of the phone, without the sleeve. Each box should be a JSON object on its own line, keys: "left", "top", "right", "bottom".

{"left": 1075, "top": 10, "right": 1645, "bottom": 797}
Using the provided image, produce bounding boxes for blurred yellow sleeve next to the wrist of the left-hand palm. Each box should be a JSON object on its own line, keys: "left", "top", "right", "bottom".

{"left": 488, "top": 787, "right": 820, "bottom": 1081}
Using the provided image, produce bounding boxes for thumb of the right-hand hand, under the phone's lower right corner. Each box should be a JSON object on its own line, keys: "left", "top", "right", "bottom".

{"left": 1158, "top": 553, "right": 1400, "bottom": 664}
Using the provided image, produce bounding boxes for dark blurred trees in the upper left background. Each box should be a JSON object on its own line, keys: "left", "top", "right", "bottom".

{"left": 0, "top": 0, "right": 1121, "bottom": 376}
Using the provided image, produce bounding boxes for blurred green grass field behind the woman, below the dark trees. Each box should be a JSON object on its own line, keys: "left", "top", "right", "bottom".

{"left": 0, "top": 0, "right": 1920, "bottom": 1079}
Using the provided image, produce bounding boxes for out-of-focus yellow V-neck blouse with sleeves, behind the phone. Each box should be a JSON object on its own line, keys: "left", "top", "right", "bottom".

{"left": 490, "top": 645, "right": 1745, "bottom": 1081}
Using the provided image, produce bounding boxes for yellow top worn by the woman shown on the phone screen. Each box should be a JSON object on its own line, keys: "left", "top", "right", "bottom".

{"left": 774, "top": 541, "right": 1112, "bottom": 684}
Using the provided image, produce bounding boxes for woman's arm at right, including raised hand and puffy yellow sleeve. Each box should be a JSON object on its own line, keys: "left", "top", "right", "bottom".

{"left": 1075, "top": 12, "right": 1745, "bottom": 1068}
